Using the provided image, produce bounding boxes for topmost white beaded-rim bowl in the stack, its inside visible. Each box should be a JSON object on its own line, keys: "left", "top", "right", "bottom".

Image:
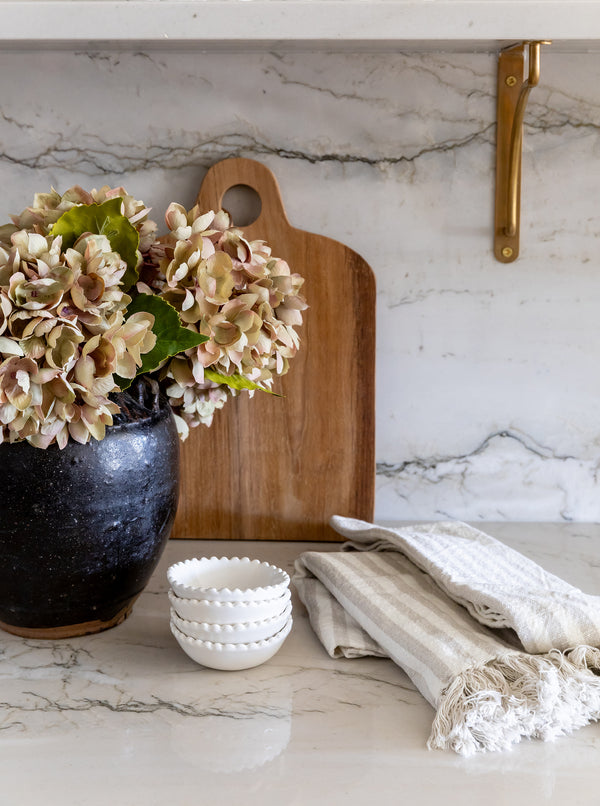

{"left": 167, "top": 557, "right": 290, "bottom": 602}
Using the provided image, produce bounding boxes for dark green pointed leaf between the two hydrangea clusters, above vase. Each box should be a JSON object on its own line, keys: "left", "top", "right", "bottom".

{"left": 115, "top": 294, "right": 208, "bottom": 390}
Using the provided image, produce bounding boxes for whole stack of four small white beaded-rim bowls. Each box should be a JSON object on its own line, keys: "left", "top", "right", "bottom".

{"left": 167, "top": 557, "right": 292, "bottom": 670}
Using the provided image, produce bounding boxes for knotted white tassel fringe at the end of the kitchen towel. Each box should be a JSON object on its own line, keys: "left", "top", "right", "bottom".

{"left": 427, "top": 647, "right": 600, "bottom": 756}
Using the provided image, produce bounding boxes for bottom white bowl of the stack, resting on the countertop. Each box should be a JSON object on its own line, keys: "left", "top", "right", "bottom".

{"left": 171, "top": 618, "right": 292, "bottom": 671}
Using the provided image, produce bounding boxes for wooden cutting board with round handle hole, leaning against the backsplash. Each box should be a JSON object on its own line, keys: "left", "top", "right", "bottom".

{"left": 172, "top": 159, "right": 375, "bottom": 540}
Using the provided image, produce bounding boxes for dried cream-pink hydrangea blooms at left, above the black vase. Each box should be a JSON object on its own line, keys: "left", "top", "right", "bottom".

{"left": 0, "top": 187, "right": 156, "bottom": 448}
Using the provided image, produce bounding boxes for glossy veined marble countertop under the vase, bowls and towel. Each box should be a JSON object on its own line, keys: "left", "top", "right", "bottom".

{"left": 0, "top": 523, "right": 600, "bottom": 806}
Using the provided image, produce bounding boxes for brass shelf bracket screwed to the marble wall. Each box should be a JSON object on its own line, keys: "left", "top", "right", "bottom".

{"left": 494, "top": 40, "right": 550, "bottom": 263}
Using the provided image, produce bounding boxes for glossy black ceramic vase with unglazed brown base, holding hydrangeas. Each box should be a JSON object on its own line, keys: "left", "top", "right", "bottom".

{"left": 0, "top": 381, "right": 179, "bottom": 638}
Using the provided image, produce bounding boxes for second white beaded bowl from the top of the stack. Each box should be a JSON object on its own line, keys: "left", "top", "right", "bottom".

{"left": 168, "top": 589, "right": 291, "bottom": 624}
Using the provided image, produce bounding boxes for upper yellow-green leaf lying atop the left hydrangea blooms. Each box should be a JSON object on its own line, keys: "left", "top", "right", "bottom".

{"left": 50, "top": 197, "right": 140, "bottom": 291}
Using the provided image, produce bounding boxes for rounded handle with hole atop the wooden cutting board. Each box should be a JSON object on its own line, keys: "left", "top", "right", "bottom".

{"left": 196, "top": 157, "right": 290, "bottom": 232}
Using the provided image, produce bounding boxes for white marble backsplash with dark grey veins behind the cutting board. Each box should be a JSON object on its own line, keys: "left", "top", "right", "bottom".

{"left": 0, "top": 48, "right": 600, "bottom": 521}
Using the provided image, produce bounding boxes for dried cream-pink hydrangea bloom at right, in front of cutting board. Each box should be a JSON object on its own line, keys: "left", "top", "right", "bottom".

{"left": 140, "top": 204, "right": 307, "bottom": 438}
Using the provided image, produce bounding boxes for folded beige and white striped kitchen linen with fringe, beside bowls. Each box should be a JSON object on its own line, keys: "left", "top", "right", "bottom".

{"left": 294, "top": 516, "right": 600, "bottom": 755}
